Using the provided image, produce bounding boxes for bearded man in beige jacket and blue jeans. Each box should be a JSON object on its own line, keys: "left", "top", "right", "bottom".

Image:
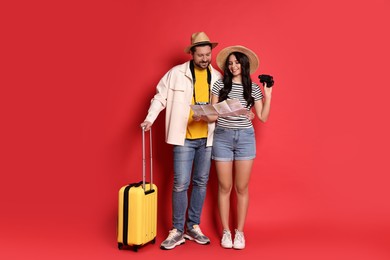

{"left": 141, "top": 32, "right": 221, "bottom": 249}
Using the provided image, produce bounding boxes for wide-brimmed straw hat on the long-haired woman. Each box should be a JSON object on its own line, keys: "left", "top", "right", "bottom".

{"left": 216, "top": 45, "right": 259, "bottom": 74}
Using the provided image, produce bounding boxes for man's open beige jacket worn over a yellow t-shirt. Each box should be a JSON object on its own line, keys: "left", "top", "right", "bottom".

{"left": 145, "top": 61, "right": 221, "bottom": 146}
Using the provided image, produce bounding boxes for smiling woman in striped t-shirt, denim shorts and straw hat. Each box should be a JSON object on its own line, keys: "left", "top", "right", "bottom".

{"left": 211, "top": 46, "right": 273, "bottom": 249}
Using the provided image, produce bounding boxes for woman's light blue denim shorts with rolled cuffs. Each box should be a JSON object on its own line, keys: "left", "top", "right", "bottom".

{"left": 212, "top": 126, "right": 256, "bottom": 161}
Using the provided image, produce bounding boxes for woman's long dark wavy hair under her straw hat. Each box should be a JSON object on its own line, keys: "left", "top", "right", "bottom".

{"left": 219, "top": 52, "right": 254, "bottom": 107}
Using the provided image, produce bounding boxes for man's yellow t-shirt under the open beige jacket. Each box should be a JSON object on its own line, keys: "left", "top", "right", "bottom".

{"left": 186, "top": 67, "right": 210, "bottom": 139}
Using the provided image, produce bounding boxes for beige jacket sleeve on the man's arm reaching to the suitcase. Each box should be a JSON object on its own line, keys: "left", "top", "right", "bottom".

{"left": 144, "top": 70, "right": 172, "bottom": 123}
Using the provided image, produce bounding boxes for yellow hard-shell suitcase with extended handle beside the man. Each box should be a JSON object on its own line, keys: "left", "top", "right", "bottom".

{"left": 117, "top": 129, "right": 157, "bottom": 251}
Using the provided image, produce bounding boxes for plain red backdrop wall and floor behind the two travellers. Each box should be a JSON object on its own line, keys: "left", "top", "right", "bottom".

{"left": 0, "top": 0, "right": 390, "bottom": 259}
